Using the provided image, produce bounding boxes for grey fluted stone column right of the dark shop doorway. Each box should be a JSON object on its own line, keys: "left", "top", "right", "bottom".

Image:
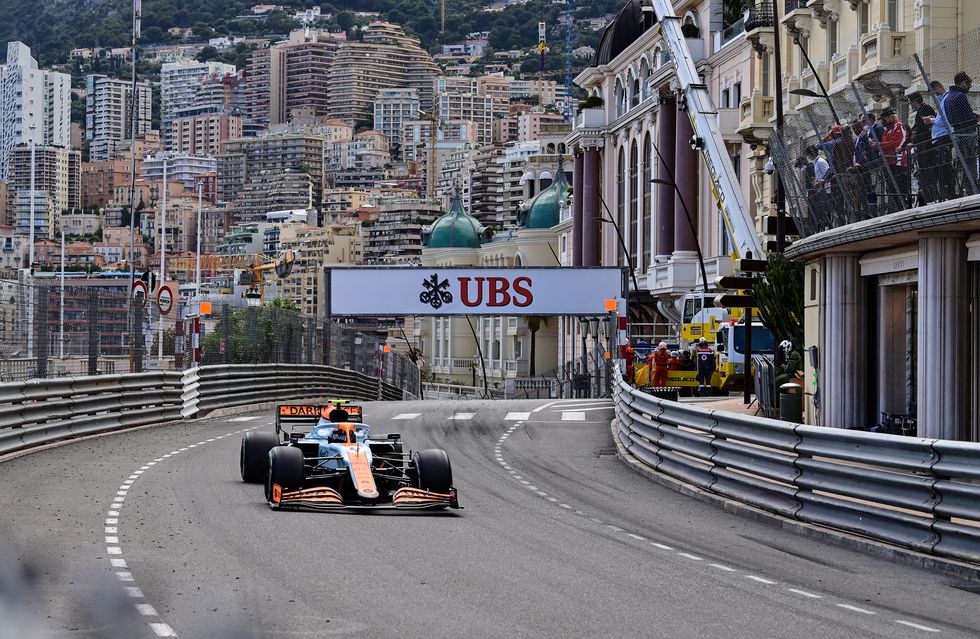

{"left": 916, "top": 233, "right": 970, "bottom": 439}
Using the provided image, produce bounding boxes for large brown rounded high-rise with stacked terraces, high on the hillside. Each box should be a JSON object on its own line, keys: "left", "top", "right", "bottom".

{"left": 327, "top": 21, "right": 438, "bottom": 125}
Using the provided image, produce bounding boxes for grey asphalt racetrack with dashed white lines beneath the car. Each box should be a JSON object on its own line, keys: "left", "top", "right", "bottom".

{"left": 0, "top": 400, "right": 980, "bottom": 639}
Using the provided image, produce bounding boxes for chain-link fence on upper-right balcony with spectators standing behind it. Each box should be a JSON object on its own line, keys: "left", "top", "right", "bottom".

{"left": 769, "top": 29, "right": 980, "bottom": 237}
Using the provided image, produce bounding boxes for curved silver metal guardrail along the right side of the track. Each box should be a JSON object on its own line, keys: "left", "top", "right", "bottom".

{"left": 614, "top": 383, "right": 980, "bottom": 562}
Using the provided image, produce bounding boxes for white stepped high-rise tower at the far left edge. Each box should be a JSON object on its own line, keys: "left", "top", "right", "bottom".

{"left": 0, "top": 42, "right": 71, "bottom": 180}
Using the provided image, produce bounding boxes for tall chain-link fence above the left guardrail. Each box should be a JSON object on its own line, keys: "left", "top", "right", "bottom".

{"left": 0, "top": 276, "right": 419, "bottom": 394}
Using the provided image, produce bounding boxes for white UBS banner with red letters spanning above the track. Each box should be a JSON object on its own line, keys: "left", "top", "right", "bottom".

{"left": 326, "top": 266, "right": 624, "bottom": 316}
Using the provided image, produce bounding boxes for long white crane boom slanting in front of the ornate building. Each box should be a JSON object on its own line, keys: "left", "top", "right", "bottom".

{"left": 650, "top": 0, "right": 763, "bottom": 259}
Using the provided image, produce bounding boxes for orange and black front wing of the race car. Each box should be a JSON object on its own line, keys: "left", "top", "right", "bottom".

{"left": 269, "top": 484, "right": 462, "bottom": 510}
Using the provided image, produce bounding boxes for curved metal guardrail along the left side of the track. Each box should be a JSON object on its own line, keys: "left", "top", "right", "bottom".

{"left": 0, "top": 364, "right": 406, "bottom": 454}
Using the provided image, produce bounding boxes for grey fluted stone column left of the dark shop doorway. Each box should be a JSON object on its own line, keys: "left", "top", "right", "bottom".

{"left": 819, "top": 255, "right": 871, "bottom": 428}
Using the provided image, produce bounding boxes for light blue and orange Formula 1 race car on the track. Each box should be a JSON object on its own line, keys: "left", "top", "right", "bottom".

{"left": 240, "top": 400, "right": 460, "bottom": 510}
